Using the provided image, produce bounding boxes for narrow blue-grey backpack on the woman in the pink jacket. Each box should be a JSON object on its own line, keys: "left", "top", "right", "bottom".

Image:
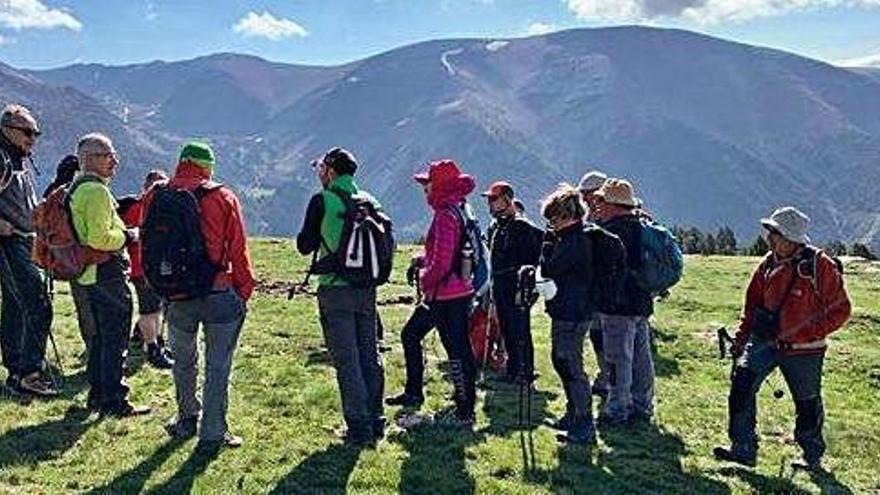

{"left": 450, "top": 201, "right": 492, "bottom": 298}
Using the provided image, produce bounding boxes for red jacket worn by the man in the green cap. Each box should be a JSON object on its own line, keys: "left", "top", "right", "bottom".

{"left": 141, "top": 162, "right": 254, "bottom": 301}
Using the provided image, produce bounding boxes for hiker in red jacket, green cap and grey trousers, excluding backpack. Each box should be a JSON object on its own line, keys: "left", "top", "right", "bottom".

{"left": 142, "top": 141, "right": 254, "bottom": 452}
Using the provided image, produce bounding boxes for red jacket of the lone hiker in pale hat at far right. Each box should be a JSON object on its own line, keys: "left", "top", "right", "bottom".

{"left": 736, "top": 247, "right": 852, "bottom": 354}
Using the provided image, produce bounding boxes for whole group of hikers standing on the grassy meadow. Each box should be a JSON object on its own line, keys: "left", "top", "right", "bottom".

{"left": 0, "top": 101, "right": 851, "bottom": 469}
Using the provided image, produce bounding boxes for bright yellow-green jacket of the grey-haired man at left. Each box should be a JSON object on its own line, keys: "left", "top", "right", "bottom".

{"left": 70, "top": 172, "right": 125, "bottom": 285}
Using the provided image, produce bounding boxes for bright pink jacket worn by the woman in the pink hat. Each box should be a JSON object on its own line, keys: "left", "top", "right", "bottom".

{"left": 419, "top": 170, "right": 476, "bottom": 301}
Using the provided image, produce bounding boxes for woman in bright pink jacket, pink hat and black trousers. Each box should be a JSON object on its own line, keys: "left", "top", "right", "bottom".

{"left": 413, "top": 160, "right": 476, "bottom": 428}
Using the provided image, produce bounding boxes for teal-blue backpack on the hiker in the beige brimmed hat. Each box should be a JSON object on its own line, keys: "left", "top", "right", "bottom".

{"left": 633, "top": 219, "right": 684, "bottom": 295}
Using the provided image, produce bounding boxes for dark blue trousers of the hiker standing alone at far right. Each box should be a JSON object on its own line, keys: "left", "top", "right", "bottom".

{"left": 728, "top": 337, "right": 825, "bottom": 461}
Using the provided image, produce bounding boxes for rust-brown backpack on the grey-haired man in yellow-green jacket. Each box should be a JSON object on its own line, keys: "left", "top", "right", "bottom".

{"left": 31, "top": 175, "right": 110, "bottom": 281}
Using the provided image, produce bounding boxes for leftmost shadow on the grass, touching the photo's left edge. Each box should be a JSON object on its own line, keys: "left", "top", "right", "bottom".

{"left": 0, "top": 406, "right": 97, "bottom": 470}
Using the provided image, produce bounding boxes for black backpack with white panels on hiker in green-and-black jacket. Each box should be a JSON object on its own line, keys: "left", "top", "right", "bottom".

{"left": 316, "top": 187, "right": 395, "bottom": 288}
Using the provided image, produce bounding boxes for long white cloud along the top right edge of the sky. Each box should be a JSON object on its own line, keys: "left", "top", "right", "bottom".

{"left": 563, "top": 0, "right": 880, "bottom": 24}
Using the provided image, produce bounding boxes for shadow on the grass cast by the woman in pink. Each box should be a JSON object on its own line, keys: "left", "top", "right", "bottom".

{"left": 395, "top": 425, "right": 483, "bottom": 494}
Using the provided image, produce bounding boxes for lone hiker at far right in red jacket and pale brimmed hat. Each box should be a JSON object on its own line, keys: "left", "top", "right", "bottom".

{"left": 714, "top": 206, "right": 852, "bottom": 471}
